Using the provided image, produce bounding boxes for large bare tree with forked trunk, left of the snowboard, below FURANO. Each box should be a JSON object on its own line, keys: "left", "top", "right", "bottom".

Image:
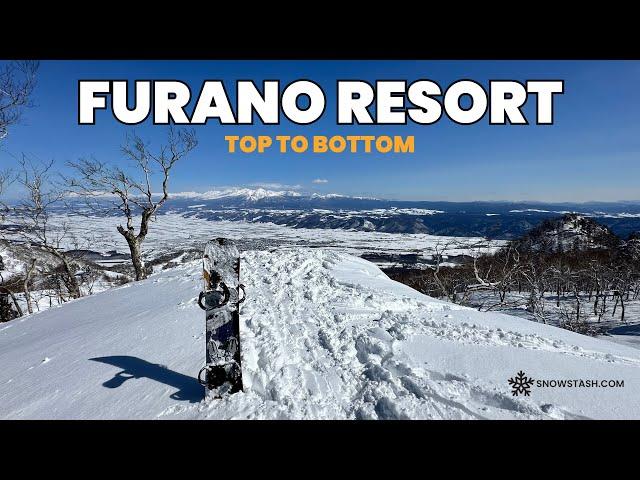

{"left": 67, "top": 128, "right": 198, "bottom": 280}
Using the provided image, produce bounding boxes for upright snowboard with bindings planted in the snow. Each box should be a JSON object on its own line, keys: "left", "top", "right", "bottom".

{"left": 198, "top": 238, "right": 244, "bottom": 396}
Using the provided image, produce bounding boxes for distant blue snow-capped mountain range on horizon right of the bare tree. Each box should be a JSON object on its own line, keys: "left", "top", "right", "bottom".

{"left": 168, "top": 188, "right": 640, "bottom": 239}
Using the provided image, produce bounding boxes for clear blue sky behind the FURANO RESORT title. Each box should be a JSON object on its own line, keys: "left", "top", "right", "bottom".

{"left": 0, "top": 61, "right": 640, "bottom": 201}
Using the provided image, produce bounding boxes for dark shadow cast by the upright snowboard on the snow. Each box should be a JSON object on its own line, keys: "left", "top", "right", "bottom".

{"left": 89, "top": 355, "right": 204, "bottom": 403}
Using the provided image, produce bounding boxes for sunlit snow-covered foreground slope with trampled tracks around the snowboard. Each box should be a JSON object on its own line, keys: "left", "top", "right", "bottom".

{"left": 0, "top": 248, "right": 640, "bottom": 419}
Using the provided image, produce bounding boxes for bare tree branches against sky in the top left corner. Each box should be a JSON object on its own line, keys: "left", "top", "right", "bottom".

{"left": 0, "top": 61, "right": 39, "bottom": 140}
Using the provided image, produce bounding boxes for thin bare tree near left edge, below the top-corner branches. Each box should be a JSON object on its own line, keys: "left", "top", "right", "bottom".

{"left": 12, "top": 156, "right": 82, "bottom": 298}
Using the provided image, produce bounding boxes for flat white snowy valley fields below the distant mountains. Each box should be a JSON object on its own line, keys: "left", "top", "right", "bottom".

{"left": 2, "top": 212, "right": 504, "bottom": 258}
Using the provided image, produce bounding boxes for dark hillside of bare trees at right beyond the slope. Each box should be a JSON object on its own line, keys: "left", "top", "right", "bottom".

{"left": 385, "top": 214, "right": 640, "bottom": 335}
